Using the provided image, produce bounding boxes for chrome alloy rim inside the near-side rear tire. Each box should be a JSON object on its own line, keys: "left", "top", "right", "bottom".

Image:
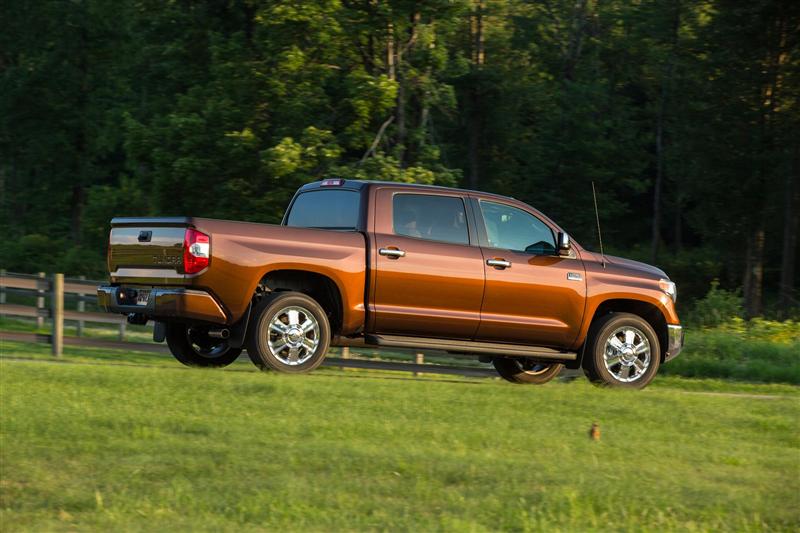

{"left": 267, "top": 306, "right": 319, "bottom": 366}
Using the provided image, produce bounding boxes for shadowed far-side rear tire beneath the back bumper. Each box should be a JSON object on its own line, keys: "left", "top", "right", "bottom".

{"left": 166, "top": 322, "right": 242, "bottom": 368}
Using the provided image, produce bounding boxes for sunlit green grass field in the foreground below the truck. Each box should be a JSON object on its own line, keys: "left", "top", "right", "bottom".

{"left": 0, "top": 342, "right": 800, "bottom": 531}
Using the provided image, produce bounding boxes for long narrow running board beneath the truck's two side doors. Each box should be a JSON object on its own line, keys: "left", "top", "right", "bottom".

{"left": 364, "top": 335, "right": 578, "bottom": 361}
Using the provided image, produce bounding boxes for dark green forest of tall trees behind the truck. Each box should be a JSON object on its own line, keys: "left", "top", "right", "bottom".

{"left": 0, "top": 0, "right": 800, "bottom": 317}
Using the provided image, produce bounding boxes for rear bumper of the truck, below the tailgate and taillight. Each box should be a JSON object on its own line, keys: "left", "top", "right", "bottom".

{"left": 97, "top": 286, "right": 227, "bottom": 324}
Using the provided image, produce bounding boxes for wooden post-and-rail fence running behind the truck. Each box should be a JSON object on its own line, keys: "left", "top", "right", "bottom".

{"left": 0, "top": 270, "right": 496, "bottom": 376}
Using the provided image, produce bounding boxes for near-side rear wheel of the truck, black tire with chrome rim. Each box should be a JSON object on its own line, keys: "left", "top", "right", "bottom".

{"left": 246, "top": 292, "right": 331, "bottom": 374}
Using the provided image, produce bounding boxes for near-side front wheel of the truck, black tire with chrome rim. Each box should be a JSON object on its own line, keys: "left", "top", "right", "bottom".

{"left": 583, "top": 313, "right": 661, "bottom": 389}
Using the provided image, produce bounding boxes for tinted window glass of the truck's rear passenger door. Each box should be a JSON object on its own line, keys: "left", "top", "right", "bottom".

{"left": 392, "top": 193, "right": 469, "bottom": 244}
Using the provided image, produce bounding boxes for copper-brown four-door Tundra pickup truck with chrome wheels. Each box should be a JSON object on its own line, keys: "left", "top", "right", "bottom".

{"left": 98, "top": 179, "right": 683, "bottom": 388}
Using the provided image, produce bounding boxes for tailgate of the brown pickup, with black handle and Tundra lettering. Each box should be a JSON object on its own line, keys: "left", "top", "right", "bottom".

{"left": 108, "top": 217, "right": 192, "bottom": 284}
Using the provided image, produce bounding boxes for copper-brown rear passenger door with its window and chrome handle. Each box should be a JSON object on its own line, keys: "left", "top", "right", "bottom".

{"left": 373, "top": 188, "right": 484, "bottom": 339}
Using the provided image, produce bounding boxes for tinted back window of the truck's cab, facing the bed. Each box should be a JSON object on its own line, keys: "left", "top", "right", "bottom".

{"left": 286, "top": 189, "right": 361, "bottom": 229}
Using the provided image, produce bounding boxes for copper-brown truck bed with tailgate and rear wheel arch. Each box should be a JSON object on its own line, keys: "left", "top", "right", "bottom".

{"left": 108, "top": 217, "right": 367, "bottom": 332}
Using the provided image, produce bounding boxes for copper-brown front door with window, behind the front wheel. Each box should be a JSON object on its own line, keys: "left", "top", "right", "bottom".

{"left": 476, "top": 200, "right": 586, "bottom": 348}
